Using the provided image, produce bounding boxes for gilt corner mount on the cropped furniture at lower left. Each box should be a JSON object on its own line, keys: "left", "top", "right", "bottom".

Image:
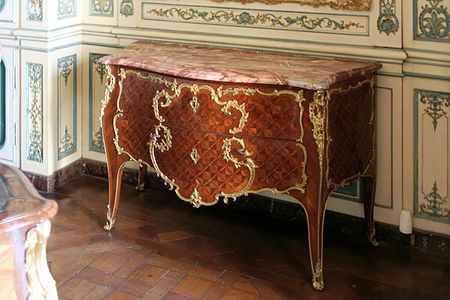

{"left": 25, "top": 221, "right": 58, "bottom": 300}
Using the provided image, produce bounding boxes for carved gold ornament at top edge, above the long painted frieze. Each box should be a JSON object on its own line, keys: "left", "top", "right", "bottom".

{"left": 210, "top": 0, "right": 372, "bottom": 10}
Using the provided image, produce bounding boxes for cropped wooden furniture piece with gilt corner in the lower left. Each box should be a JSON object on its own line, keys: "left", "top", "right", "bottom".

{"left": 0, "top": 164, "right": 58, "bottom": 299}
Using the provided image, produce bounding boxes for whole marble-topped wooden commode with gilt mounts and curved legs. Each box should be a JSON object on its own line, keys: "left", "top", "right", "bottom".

{"left": 101, "top": 41, "right": 381, "bottom": 290}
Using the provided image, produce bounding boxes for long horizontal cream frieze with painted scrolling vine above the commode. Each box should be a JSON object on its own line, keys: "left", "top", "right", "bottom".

{"left": 142, "top": 2, "right": 369, "bottom": 35}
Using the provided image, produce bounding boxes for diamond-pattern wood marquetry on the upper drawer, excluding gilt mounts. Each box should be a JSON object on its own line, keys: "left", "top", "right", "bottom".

{"left": 120, "top": 71, "right": 301, "bottom": 140}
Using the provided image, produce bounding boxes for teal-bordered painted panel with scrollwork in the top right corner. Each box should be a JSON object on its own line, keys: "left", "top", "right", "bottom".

{"left": 414, "top": 0, "right": 450, "bottom": 42}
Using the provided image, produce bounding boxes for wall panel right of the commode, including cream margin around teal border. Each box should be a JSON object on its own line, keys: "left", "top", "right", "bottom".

{"left": 403, "top": 77, "right": 450, "bottom": 234}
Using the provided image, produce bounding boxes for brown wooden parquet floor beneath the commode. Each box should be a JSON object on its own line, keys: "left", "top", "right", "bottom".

{"left": 45, "top": 176, "right": 450, "bottom": 300}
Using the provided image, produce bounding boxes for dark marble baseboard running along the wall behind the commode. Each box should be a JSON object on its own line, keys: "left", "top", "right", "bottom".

{"left": 24, "top": 158, "right": 450, "bottom": 259}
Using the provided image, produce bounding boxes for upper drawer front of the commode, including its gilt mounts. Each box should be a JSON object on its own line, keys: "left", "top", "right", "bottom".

{"left": 118, "top": 69, "right": 305, "bottom": 140}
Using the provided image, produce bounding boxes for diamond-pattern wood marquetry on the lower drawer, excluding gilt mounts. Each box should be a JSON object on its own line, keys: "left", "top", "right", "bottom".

{"left": 116, "top": 114, "right": 305, "bottom": 203}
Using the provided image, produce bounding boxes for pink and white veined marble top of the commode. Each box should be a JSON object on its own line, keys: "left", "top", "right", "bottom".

{"left": 100, "top": 41, "right": 381, "bottom": 90}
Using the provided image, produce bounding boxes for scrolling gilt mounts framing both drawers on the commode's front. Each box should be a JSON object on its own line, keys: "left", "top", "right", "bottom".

{"left": 113, "top": 69, "right": 308, "bottom": 207}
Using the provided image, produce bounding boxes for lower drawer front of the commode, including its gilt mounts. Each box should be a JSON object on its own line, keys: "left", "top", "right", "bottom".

{"left": 114, "top": 113, "right": 307, "bottom": 206}
